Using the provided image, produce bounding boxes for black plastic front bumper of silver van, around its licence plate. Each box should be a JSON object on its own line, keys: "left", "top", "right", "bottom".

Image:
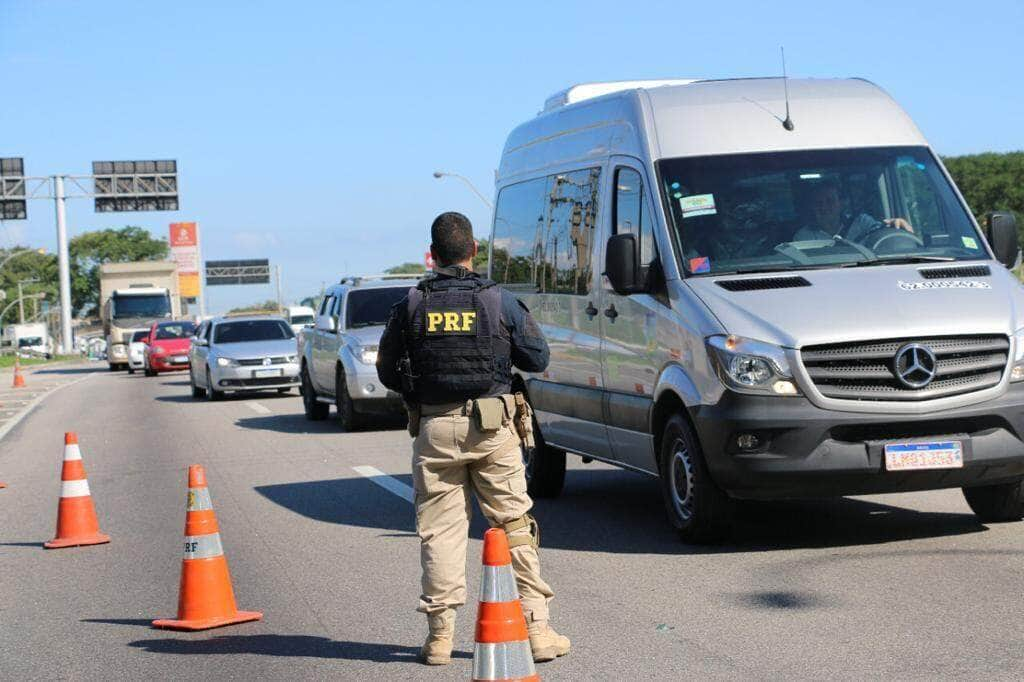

{"left": 693, "top": 384, "right": 1024, "bottom": 499}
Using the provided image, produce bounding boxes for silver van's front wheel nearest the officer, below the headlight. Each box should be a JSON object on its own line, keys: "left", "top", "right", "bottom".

{"left": 659, "top": 415, "right": 732, "bottom": 545}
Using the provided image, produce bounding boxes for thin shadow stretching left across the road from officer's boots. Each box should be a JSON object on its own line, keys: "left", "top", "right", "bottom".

{"left": 128, "top": 635, "right": 473, "bottom": 663}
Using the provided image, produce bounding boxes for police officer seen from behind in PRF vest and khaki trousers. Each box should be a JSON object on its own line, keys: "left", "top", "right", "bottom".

{"left": 377, "top": 213, "right": 569, "bottom": 665}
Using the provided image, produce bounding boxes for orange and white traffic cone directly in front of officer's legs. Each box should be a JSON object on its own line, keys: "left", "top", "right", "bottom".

{"left": 473, "top": 528, "right": 541, "bottom": 681}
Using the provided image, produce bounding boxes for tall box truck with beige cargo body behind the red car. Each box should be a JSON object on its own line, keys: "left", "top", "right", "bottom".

{"left": 99, "top": 261, "right": 181, "bottom": 371}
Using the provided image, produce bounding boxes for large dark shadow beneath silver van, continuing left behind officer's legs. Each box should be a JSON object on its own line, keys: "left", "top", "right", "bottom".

{"left": 255, "top": 469, "right": 987, "bottom": 557}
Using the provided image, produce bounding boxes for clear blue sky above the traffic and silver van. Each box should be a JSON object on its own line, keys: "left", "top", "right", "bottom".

{"left": 0, "top": 0, "right": 1024, "bottom": 311}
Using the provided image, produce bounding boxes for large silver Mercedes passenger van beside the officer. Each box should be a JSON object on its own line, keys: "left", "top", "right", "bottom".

{"left": 489, "top": 78, "right": 1024, "bottom": 542}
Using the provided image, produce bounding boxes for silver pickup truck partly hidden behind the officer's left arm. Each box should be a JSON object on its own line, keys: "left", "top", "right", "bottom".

{"left": 298, "top": 274, "right": 417, "bottom": 431}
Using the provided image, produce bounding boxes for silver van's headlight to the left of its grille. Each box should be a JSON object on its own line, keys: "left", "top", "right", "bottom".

{"left": 707, "top": 336, "right": 800, "bottom": 395}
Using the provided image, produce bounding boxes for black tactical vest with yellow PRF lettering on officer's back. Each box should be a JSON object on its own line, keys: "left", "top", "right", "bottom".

{"left": 407, "top": 276, "right": 512, "bottom": 404}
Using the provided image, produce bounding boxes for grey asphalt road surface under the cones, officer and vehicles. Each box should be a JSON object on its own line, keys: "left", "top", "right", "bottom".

{"left": 0, "top": 367, "right": 1024, "bottom": 680}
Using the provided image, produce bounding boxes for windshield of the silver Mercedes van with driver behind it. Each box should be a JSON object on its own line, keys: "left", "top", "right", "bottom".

{"left": 657, "top": 146, "right": 989, "bottom": 274}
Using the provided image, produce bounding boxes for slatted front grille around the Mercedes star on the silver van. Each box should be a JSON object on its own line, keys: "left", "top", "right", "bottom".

{"left": 800, "top": 336, "right": 1010, "bottom": 401}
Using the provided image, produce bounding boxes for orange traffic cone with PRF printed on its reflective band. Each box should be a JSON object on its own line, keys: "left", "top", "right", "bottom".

{"left": 153, "top": 464, "right": 263, "bottom": 630}
